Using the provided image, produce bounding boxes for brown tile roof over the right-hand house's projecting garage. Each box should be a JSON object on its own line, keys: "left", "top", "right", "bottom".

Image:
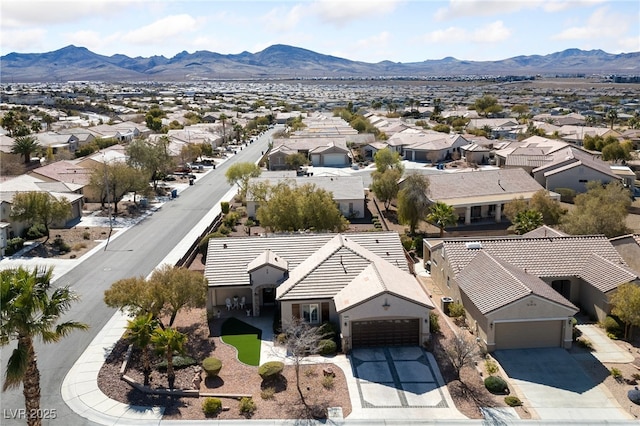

{"left": 456, "top": 251, "right": 578, "bottom": 314}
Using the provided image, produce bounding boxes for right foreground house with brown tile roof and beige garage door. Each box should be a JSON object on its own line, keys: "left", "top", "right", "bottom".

{"left": 424, "top": 234, "right": 640, "bottom": 352}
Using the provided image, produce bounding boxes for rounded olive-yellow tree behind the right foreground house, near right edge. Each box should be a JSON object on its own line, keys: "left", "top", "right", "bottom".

{"left": 560, "top": 181, "right": 631, "bottom": 238}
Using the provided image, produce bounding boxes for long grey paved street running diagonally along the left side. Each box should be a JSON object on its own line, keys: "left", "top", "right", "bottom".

{"left": 0, "top": 134, "right": 269, "bottom": 426}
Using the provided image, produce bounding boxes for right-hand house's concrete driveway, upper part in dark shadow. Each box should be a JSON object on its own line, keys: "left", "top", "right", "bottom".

{"left": 494, "top": 348, "right": 631, "bottom": 423}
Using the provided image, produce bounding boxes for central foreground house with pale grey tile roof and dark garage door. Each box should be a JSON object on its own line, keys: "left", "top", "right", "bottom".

{"left": 205, "top": 232, "right": 433, "bottom": 351}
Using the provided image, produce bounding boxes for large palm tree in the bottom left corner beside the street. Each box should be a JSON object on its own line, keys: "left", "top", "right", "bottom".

{"left": 0, "top": 267, "right": 88, "bottom": 426}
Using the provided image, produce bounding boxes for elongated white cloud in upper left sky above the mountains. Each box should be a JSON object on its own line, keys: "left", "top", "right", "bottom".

{"left": 121, "top": 14, "right": 201, "bottom": 44}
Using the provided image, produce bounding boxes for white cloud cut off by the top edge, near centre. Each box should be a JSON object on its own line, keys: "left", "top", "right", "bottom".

{"left": 309, "top": 0, "right": 402, "bottom": 27}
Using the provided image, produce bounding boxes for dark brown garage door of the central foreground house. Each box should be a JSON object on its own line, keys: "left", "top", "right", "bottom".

{"left": 351, "top": 318, "right": 420, "bottom": 348}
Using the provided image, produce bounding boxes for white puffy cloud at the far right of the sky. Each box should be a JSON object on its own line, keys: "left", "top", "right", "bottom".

{"left": 550, "top": 7, "right": 631, "bottom": 40}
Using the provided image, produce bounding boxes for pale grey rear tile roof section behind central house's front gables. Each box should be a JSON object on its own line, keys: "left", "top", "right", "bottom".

{"left": 204, "top": 232, "right": 409, "bottom": 287}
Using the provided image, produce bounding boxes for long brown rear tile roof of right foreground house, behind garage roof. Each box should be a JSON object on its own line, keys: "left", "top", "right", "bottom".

{"left": 442, "top": 235, "right": 638, "bottom": 292}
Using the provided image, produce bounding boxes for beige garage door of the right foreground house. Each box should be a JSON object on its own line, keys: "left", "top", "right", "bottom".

{"left": 495, "top": 320, "right": 564, "bottom": 349}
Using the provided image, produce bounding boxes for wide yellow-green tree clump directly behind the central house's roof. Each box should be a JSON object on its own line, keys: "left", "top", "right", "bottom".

{"left": 256, "top": 181, "right": 349, "bottom": 232}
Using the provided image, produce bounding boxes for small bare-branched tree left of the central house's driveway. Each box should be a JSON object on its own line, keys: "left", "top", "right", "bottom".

{"left": 282, "top": 318, "right": 327, "bottom": 411}
